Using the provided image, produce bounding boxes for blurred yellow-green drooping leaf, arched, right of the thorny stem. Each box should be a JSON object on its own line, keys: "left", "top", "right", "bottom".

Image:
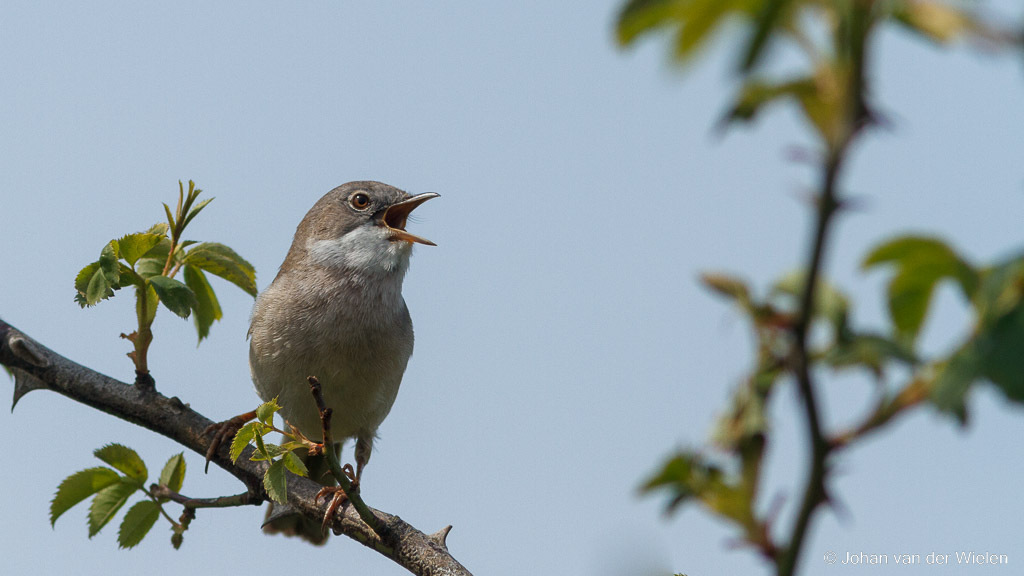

{"left": 861, "top": 236, "right": 978, "bottom": 343}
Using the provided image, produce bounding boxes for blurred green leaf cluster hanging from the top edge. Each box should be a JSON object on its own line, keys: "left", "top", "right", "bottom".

{"left": 615, "top": 0, "right": 1017, "bottom": 148}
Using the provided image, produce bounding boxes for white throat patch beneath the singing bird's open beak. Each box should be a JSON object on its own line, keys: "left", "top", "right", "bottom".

{"left": 306, "top": 225, "right": 413, "bottom": 282}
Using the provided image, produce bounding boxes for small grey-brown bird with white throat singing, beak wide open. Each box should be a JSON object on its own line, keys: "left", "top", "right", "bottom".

{"left": 249, "top": 180, "right": 439, "bottom": 542}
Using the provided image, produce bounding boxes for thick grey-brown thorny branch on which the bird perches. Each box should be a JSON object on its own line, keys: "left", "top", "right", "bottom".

{"left": 0, "top": 320, "right": 470, "bottom": 576}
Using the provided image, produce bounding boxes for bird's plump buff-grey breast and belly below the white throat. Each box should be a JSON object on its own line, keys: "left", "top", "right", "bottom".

{"left": 250, "top": 268, "right": 413, "bottom": 438}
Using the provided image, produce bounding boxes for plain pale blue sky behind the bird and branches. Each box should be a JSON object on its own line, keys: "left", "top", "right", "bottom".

{"left": 0, "top": 0, "right": 1024, "bottom": 576}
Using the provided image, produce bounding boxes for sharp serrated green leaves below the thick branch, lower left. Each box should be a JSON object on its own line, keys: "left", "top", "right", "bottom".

{"left": 50, "top": 444, "right": 185, "bottom": 548}
